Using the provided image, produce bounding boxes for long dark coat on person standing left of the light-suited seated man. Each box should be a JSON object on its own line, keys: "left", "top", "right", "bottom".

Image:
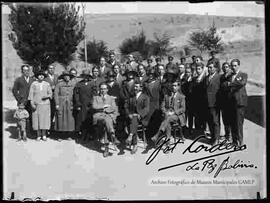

{"left": 73, "top": 80, "right": 93, "bottom": 130}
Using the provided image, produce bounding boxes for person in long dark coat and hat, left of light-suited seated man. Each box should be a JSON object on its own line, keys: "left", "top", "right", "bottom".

{"left": 73, "top": 69, "right": 93, "bottom": 142}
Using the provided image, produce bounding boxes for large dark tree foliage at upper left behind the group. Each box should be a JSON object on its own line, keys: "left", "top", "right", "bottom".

{"left": 9, "top": 3, "right": 85, "bottom": 71}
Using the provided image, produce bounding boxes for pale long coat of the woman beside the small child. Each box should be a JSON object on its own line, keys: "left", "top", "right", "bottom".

{"left": 28, "top": 81, "right": 52, "bottom": 130}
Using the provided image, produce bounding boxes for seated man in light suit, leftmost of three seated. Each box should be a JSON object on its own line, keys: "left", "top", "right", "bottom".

{"left": 93, "top": 82, "right": 120, "bottom": 157}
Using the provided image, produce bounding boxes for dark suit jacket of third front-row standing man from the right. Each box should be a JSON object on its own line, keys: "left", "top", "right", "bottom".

{"left": 205, "top": 72, "right": 220, "bottom": 107}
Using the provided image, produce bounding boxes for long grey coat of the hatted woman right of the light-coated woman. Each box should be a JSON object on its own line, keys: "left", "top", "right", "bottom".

{"left": 54, "top": 81, "right": 75, "bottom": 132}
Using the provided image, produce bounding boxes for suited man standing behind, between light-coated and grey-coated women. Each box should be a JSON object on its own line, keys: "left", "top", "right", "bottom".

{"left": 44, "top": 64, "right": 59, "bottom": 132}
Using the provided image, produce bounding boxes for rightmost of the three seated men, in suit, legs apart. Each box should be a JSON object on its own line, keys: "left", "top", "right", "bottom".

{"left": 152, "top": 81, "right": 186, "bottom": 145}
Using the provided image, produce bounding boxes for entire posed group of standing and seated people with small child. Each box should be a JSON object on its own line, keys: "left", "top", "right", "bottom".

{"left": 12, "top": 51, "right": 247, "bottom": 157}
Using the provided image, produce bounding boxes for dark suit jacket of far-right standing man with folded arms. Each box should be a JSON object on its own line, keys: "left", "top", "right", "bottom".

{"left": 229, "top": 71, "right": 248, "bottom": 106}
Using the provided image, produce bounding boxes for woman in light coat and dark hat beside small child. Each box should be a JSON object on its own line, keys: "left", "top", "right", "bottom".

{"left": 28, "top": 71, "right": 52, "bottom": 141}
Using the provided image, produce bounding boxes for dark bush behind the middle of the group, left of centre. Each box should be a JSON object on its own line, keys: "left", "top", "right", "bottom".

{"left": 119, "top": 31, "right": 150, "bottom": 59}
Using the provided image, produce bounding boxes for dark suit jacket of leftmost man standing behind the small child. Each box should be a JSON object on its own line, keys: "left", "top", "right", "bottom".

{"left": 12, "top": 76, "right": 35, "bottom": 104}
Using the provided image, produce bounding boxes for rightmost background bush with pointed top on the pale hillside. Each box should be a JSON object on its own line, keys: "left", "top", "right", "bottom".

{"left": 188, "top": 22, "right": 224, "bottom": 54}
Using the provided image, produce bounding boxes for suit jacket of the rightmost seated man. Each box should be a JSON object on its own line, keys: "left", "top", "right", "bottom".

{"left": 161, "top": 92, "right": 186, "bottom": 126}
